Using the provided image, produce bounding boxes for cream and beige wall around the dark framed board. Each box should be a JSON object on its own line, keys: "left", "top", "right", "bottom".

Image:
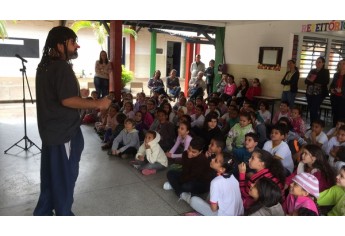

{"left": 224, "top": 21, "right": 320, "bottom": 97}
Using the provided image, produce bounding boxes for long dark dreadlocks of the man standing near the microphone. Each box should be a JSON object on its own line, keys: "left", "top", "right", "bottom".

{"left": 37, "top": 26, "right": 77, "bottom": 71}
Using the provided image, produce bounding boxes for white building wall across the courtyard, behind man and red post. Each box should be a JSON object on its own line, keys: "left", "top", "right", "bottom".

{"left": 0, "top": 20, "right": 202, "bottom": 100}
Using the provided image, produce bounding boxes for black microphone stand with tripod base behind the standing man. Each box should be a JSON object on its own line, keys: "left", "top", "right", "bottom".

{"left": 4, "top": 58, "right": 41, "bottom": 154}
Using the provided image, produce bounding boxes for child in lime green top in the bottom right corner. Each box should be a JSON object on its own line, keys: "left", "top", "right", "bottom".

{"left": 317, "top": 165, "right": 345, "bottom": 216}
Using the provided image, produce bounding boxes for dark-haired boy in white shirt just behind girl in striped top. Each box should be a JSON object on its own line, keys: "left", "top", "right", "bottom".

{"left": 262, "top": 124, "right": 294, "bottom": 176}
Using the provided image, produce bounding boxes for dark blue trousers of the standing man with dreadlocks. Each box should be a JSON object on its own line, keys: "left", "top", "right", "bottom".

{"left": 33, "top": 128, "right": 84, "bottom": 216}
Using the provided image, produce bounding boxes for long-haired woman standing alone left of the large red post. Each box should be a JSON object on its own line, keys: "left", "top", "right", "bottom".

{"left": 93, "top": 51, "right": 111, "bottom": 98}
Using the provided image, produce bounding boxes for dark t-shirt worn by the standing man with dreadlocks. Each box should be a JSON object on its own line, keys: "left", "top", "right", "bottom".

{"left": 36, "top": 60, "right": 80, "bottom": 145}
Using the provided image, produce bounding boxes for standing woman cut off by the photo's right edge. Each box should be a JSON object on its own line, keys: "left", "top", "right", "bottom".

{"left": 330, "top": 59, "right": 345, "bottom": 127}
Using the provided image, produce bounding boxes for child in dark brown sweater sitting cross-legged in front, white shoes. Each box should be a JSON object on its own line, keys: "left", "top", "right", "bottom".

{"left": 163, "top": 137, "right": 211, "bottom": 197}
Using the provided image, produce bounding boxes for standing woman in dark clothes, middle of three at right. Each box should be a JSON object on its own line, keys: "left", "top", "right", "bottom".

{"left": 304, "top": 57, "right": 329, "bottom": 123}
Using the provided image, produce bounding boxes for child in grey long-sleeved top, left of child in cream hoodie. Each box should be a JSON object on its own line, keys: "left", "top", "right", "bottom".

{"left": 109, "top": 118, "right": 140, "bottom": 159}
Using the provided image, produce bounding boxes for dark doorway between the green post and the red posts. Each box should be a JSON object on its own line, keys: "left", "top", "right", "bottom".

{"left": 166, "top": 41, "right": 181, "bottom": 77}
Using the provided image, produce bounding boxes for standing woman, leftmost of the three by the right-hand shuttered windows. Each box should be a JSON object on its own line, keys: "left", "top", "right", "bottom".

{"left": 280, "top": 60, "right": 299, "bottom": 108}
